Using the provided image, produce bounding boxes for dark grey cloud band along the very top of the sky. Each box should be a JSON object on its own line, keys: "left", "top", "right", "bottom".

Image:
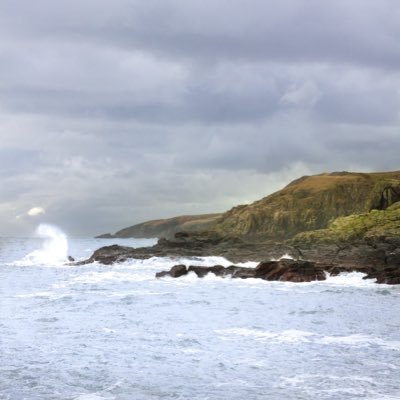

{"left": 0, "top": 0, "right": 400, "bottom": 68}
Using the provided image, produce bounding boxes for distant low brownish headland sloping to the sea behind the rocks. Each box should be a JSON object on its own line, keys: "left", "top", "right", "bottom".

{"left": 98, "top": 214, "right": 222, "bottom": 238}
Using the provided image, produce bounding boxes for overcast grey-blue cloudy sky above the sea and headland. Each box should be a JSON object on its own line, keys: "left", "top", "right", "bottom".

{"left": 0, "top": 0, "right": 400, "bottom": 236}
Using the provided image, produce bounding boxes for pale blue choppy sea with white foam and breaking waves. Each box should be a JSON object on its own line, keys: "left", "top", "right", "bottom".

{"left": 0, "top": 227, "right": 400, "bottom": 400}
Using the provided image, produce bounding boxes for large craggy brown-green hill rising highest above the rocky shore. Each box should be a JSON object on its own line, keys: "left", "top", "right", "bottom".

{"left": 214, "top": 171, "right": 400, "bottom": 240}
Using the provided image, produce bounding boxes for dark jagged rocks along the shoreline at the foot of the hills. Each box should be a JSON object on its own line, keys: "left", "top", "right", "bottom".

{"left": 75, "top": 232, "right": 400, "bottom": 284}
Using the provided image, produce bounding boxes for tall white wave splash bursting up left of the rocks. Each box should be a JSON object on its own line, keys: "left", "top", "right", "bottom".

{"left": 22, "top": 224, "right": 68, "bottom": 265}
